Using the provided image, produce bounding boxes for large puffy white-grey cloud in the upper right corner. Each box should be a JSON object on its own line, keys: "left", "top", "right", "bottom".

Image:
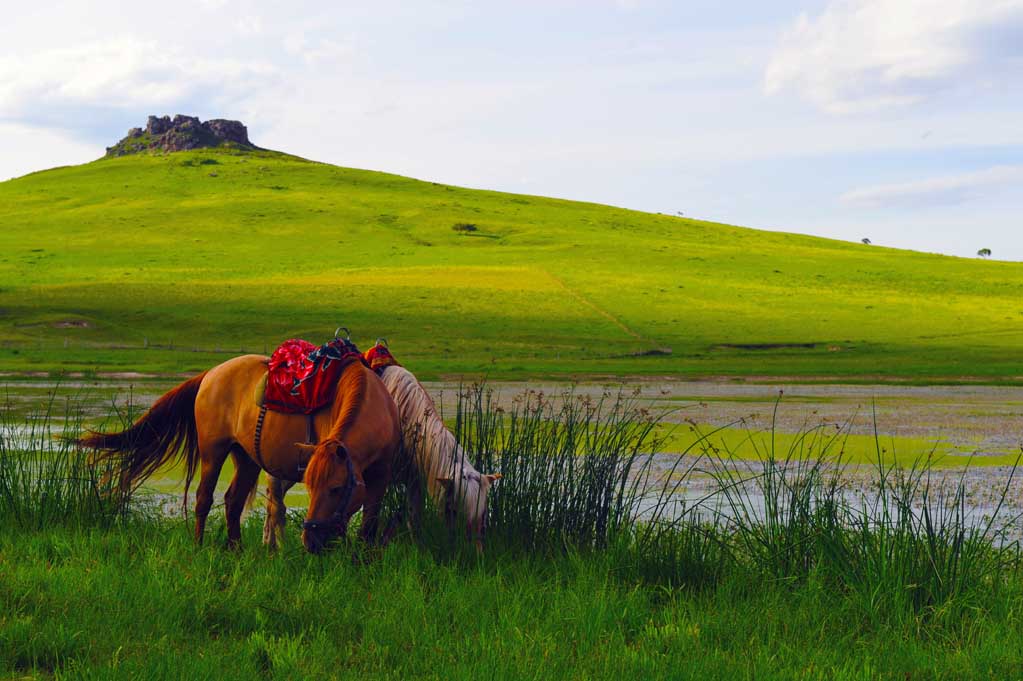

{"left": 764, "top": 0, "right": 1023, "bottom": 114}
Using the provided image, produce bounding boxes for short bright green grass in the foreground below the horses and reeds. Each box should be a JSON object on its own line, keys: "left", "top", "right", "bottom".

{"left": 0, "top": 519, "right": 1023, "bottom": 679}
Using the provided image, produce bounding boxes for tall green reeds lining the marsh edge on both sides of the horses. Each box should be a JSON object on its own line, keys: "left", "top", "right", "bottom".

{"left": 0, "top": 384, "right": 1023, "bottom": 624}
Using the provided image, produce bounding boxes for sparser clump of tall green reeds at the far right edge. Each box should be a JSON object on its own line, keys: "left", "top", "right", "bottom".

{"left": 679, "top": 408, "right": 1021, "bottom": 621}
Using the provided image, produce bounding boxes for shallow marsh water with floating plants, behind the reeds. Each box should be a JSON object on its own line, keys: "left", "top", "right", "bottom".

{"left": 7, "top": 378, "right": 1023, "bottom": 540}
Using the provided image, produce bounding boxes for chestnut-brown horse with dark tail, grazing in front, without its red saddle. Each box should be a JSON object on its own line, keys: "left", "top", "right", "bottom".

{"left": 80, "top": 355, "right": 401, "bottom": 553}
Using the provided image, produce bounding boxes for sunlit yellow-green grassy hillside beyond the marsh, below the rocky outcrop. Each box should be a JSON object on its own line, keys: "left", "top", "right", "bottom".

{"left": 0, "top": 149, "right": 1023, "bottom": 381}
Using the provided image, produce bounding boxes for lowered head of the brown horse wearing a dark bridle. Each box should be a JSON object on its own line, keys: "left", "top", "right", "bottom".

{"left": 296, "top": 440, "right": 365, "bottom": 553}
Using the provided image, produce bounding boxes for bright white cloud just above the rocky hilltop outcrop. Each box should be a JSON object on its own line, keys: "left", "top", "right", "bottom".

{"left": 0, "top": 39, "right": 277, "bottom": 134}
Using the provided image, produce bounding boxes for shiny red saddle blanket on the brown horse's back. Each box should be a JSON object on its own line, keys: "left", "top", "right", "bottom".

{"left": 263, "top": 338, "right": 364, "bottom": 414}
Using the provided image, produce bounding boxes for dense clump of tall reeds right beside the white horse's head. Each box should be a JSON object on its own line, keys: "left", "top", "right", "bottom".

{"left": 455, "top": 384, "right": 657, "bottom": 548}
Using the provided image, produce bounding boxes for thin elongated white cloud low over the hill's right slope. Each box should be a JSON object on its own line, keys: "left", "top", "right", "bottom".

{"left": 840, "top": 166, "right": 1023, "bottom": 208}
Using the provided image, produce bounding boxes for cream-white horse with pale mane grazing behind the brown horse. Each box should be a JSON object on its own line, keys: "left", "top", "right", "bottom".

{"left": 263, "top": 365, "right": 501, "bottom": 550}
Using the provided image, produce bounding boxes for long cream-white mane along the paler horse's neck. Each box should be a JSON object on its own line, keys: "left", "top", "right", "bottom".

{"left": 383, "top": 366, "right": 479, "bottom": 500}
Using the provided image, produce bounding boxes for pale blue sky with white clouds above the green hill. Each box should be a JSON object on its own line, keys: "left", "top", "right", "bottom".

{"left": 0, "top": 0, "right": 1023, "bottom": 261}
